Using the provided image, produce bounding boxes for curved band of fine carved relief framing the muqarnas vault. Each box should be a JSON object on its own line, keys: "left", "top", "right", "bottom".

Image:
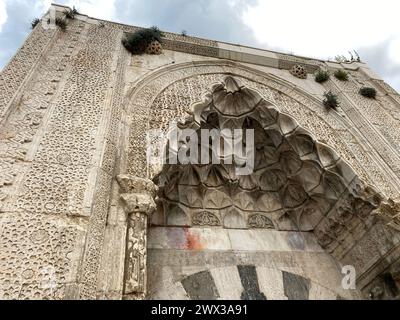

{"left": 129, "top": 63, "right": 399, "bottom": 201}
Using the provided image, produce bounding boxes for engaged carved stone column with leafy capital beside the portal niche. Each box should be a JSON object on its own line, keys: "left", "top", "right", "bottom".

{"left": 117, "top": 175, "right": 157, "bottom": 299}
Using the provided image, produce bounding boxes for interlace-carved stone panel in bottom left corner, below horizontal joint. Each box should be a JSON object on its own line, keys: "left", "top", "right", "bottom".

{"left": 0, "top": 213, "right": 82, "bottom": 300}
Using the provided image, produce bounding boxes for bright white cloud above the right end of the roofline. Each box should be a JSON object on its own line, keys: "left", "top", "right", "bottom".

{"left": 243, "top": 0, "right": 400, "bottom": 58}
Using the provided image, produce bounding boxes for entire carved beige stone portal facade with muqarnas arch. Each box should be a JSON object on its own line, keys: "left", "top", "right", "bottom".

{"left": 0, "top": 5, "right": 400, "bottom": 299}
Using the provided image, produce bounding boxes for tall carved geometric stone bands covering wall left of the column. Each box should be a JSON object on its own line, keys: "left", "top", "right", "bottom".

{"left": 0, "top": 19, "right": 126, "bottom": 299}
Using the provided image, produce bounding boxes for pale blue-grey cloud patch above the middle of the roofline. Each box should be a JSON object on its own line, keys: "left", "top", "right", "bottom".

{"left": 116, "top": 0, "right": 257, "bottom": 45}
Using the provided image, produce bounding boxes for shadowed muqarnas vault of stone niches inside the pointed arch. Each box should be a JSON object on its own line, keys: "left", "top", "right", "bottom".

{"left": 150, "top": 76, "right": 396, "bottom": 257}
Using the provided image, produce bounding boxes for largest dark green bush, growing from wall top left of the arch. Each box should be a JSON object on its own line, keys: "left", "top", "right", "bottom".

{"left": 122, "top": 27, "right": 164, "bottom": 54}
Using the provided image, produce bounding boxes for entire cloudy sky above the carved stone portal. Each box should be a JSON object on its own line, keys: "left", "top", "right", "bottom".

{"left": 0, "top": 0, "right": 400, "bottom": 91}
